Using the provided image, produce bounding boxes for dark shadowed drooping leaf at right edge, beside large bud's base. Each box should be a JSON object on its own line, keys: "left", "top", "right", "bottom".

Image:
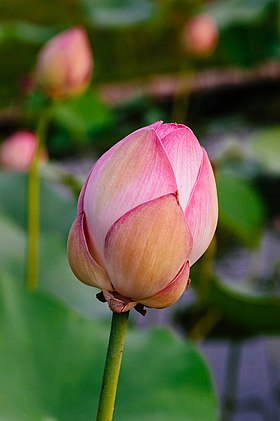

{"left": 175, "top": 267, "right": 280, "bottom": 340}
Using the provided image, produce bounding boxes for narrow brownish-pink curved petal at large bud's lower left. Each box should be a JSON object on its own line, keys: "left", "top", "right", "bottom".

{"left": 67, "top": 213, "right": 113, "bottom": 290}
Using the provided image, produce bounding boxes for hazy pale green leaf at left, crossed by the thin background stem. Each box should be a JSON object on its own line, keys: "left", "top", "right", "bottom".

{"left": 0, "top": 173, "right": 107, "bottom": 317}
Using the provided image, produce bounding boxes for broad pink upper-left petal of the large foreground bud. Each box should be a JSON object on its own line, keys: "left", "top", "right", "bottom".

{"left": 82, "top": 128, "right": 177, "bottom": 257}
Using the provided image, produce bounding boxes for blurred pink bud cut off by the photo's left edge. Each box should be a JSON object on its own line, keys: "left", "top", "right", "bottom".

{"left": 0, "top": 131, "right": 47, "bottom": 172}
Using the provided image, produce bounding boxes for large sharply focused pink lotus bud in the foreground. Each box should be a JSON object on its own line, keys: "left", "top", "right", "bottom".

{"left": 68, "top": 122, "right": 218, "bottom": 312}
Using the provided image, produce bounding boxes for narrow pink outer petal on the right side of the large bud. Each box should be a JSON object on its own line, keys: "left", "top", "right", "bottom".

{"left": 186, "top": 149, "right": 218, "bottom": 266}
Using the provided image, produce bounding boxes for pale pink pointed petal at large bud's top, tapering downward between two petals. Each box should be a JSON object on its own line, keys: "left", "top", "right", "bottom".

{"left": 162, "top": 126, "right": 203, "bottom": 211}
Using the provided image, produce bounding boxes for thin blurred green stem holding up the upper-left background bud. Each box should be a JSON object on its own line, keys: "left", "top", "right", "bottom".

{"left": 26, "top": 111, "right": 49, "bottom": 291}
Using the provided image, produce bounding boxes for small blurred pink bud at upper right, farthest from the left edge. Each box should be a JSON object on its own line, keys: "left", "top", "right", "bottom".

{"left": 182, "top": 14, "right": 219, "bottom": 56}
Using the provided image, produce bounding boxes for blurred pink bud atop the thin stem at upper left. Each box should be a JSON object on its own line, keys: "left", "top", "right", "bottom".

{"left": 35, "top": 28, "right": 93, "bottom": 98}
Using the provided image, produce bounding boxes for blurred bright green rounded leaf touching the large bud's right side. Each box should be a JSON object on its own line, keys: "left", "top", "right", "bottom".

{"left": 217, "top": 173, "right": 265, "bottom": 247}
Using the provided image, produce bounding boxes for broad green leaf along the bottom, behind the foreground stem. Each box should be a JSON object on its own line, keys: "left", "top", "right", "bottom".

{"left": 0, "top": 278, "right": 217, "bottom": 421}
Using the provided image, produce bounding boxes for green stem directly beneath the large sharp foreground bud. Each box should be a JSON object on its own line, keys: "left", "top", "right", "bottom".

{"left": 96, "top": 312, "right": 129, "bottom": 421}
